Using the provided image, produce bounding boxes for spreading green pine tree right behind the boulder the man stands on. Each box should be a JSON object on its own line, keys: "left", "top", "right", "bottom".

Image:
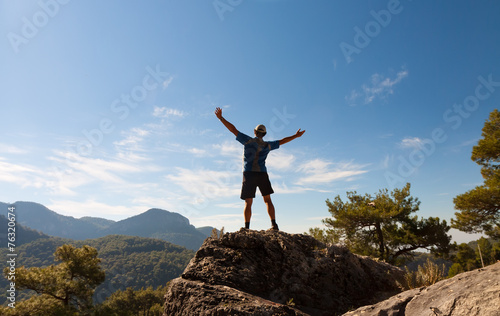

{"left": 310, "top": 183, "right": 451, "bottom": 263}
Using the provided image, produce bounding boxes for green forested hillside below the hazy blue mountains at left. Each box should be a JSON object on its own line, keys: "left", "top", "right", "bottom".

{"left": 0, "top": 235, "right": 195, "bottom": 304}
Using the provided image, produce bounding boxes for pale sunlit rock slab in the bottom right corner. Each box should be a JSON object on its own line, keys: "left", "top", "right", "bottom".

{"left": 344, "top": 263, "right": 500, "bottom": 316}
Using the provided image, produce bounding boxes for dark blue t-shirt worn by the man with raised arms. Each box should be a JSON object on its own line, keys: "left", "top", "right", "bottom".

{"left": 236, "top": 132, "right": 280, "bottom": 172}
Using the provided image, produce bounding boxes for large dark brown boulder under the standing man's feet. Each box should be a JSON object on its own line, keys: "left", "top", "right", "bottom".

{"left": 164, "top": 229, "right": 402, "bottom": 315}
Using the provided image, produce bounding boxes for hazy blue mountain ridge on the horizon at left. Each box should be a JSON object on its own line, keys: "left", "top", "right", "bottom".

{"left": 0, "top": 201, "right": 213, "bottom": 250}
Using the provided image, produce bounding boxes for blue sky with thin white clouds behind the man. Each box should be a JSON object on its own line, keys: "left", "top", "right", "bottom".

{"left": 0, "top": 0, "right": 500, "bottom": 242}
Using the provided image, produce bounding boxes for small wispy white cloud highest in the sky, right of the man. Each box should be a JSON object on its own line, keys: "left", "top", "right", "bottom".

{"left": 345, "top": 69, "right": 408, "bottom": 105}
